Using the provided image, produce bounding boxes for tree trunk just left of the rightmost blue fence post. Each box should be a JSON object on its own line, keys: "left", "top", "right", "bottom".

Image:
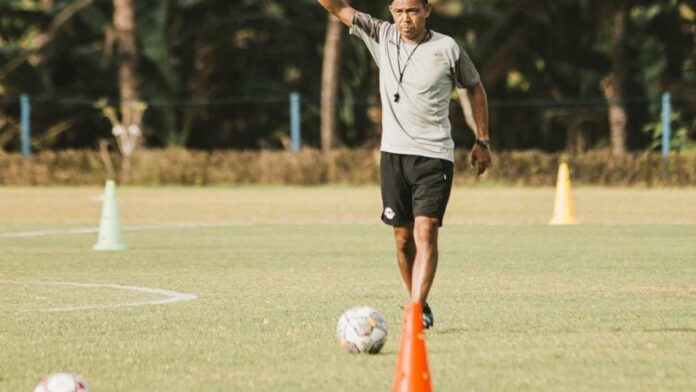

{"left": 602, "top": 0, "right": 628, "bottom": 156}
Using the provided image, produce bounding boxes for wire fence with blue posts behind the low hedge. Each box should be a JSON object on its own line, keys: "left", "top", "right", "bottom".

{"left": 0, "top": 92, "right": 694, "bottom": 159}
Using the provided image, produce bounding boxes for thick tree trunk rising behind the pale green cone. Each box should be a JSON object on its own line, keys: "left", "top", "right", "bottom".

{"left": 113, "top": 0, "right": 144, "bottom": 182}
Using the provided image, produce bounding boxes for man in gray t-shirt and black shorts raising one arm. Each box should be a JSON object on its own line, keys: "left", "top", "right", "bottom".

{"left": 318, "top": 0, "right": 491, "bottom": 328}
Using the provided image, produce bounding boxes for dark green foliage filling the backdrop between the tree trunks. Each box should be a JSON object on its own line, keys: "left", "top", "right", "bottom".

{"left": 0, "top": 0, "right": 696, "bottom": 151}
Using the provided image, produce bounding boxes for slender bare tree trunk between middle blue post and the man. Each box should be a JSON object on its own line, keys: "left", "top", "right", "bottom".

{"left": 321, "top": 15, "right": 343, "bottom": 153}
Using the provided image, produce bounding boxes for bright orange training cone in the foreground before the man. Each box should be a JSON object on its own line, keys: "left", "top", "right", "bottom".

{"left": 392, "top": 302, "right": 433, "bottom": 392}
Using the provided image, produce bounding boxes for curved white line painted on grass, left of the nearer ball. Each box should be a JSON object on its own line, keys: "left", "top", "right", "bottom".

{"left": 0, "top": 280, "right": 198, "bottom": 313}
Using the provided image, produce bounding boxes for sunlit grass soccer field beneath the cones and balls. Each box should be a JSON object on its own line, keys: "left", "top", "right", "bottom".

{"left": 0, "top": 187, "right": 696, "bottom": 392}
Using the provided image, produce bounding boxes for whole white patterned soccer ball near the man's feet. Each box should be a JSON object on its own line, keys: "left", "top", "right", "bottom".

{"left": 336, "top": 306, "right": 387, "bottom": 354}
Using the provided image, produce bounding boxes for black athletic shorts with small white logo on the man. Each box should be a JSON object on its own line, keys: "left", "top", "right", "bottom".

{"left": 380, "top": 152, "right": 454, "bottom": 226}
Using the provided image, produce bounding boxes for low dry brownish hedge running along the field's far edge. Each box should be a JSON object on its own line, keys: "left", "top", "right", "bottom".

{"left": 0, "top": 149, "right": 696, "bottom": 186}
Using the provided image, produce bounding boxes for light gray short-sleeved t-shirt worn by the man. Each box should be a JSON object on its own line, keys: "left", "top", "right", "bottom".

{"left": 350, "top": 12, "right": 480, "bottom": 161}
